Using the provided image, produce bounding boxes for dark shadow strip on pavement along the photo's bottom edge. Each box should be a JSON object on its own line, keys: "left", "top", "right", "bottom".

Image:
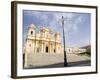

{"left": 24, "top": 60, "right": 91, "bottom": 69}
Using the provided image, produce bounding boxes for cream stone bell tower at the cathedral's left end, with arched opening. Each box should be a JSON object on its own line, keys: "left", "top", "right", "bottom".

{"left": 24, "top": 24, "right": 36, "bottom": 67}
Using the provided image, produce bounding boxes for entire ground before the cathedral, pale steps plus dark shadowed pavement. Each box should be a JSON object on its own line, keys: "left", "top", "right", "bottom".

{"left": 24, "top": 53, "right": 90, "bottom": 68}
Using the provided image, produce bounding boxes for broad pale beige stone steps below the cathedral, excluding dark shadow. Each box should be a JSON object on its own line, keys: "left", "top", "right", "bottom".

{"left": 24, "top": 53, "right": 90, "bottom": 67}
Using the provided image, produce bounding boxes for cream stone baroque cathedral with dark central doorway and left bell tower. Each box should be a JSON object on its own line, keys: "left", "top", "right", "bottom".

{"left": 24, "top": 24, "right": 62, "bottom": 67}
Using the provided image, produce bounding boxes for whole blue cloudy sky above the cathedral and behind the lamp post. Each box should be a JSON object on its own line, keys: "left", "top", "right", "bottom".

{"left": 23, "top": 10, "right": 91, "bottom": 47}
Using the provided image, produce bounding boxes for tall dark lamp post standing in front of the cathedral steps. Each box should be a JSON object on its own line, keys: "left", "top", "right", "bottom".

{"left": 61, "top": 16, "right": 68, "bottom": 67}
